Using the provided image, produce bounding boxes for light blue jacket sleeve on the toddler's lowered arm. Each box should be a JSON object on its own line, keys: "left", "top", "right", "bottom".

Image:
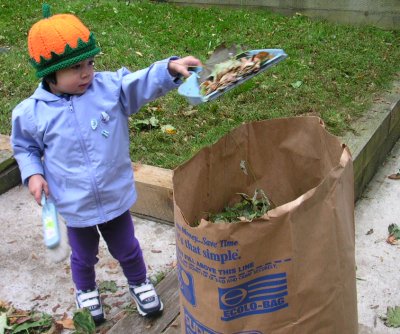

{"left": 11, "top": 101, "right": 44, "bottom": 185}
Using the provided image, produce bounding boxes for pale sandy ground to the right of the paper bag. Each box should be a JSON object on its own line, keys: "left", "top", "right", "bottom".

{"left": 355, "top": 141, "right": 400, "bottom": 333}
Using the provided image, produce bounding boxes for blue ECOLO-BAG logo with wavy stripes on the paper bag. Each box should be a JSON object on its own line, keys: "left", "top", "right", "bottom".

{"left": 218, "top": 273, "right": 288, "bottom": 321}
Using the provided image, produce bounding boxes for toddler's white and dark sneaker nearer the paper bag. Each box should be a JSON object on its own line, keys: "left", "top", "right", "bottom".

{"left": 129, "top": 278, "right": 163, "bottom": 317}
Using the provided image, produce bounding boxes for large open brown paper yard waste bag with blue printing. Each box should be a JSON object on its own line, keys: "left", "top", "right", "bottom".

{"left": 173, "top": 117, "right": 358, "bottom": 334}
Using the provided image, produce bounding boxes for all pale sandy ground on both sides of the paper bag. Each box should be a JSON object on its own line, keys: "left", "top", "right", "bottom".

{"left": 0, "top": 138, "right": 400, "bottom": 334}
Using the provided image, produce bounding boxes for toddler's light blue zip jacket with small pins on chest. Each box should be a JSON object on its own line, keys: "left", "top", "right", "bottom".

{"left": 11, "top": 59, "right": 178, "bottom": 227}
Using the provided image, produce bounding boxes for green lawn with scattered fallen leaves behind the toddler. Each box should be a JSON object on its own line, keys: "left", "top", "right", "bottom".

{"left": 0, "top": 0, "right": 400, "bottom": 168}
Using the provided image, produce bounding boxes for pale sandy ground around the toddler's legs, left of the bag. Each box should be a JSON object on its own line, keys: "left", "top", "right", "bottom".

{"left": 0, "top": 186, "right": 175, "bottom": 328}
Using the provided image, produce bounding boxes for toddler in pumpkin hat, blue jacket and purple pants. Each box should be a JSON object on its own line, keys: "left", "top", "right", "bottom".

{"left": 11, "top": 5, "right": 201, "bottom": 323}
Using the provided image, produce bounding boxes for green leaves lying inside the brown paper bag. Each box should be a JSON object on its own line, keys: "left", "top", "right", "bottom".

{"left": 200, "top": 189, "right": 273, "bottom": 224}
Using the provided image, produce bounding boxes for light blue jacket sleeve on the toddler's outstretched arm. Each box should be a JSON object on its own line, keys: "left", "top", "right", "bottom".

{"left": 120, "top": 57, "right": 180, "bottom": 114}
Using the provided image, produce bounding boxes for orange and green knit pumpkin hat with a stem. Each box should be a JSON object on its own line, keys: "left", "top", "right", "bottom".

{"left": 28, "top": 4, "right": 100, "bottom": 78}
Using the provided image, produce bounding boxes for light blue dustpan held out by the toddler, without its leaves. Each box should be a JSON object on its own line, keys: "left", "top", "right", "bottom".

{"left": 178, "top": 49, "right": 287, "bottom": 105}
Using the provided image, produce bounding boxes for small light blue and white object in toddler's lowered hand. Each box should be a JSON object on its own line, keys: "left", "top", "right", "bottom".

{"left": 41, "top": 193, "right": 61, "bottom": 249}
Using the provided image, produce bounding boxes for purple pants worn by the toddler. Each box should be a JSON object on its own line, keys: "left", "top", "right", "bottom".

{"left": 68, "top": 211, "right": 146, "bottom": 290}
